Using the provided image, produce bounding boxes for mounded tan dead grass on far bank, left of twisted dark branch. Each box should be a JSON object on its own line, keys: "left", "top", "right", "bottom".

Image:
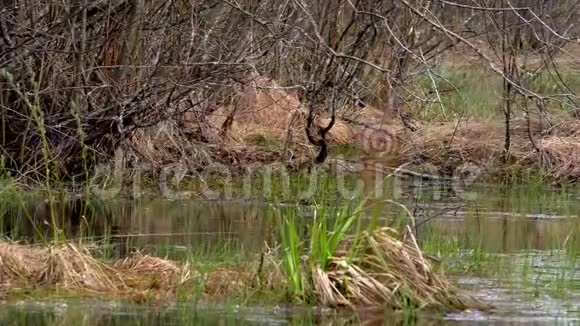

{"left": 124, "top": 77, "right": 355, "bottom": 171}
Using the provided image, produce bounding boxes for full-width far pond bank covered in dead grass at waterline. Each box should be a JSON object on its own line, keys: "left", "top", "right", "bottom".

{"left": 0, "top": 104, "right": 580, "bottom": 191}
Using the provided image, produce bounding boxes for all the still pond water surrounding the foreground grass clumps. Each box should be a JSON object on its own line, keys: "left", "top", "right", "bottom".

{"left": 0, "top": 185, "right": 580, "bottom": 325}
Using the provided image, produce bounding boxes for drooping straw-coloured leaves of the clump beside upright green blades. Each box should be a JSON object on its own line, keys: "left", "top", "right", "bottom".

{"left": 312, "top": 228, "right": 486, "bottom": 311}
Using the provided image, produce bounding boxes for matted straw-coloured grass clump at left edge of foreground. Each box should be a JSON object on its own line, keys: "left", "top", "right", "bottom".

{"left": 0, "top": 242, "right": 190, "bottom": 299}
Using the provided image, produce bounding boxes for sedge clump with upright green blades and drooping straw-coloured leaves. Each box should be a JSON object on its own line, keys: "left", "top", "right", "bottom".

{"left": 281, "top": 202, "right": 485, "bottom": 310}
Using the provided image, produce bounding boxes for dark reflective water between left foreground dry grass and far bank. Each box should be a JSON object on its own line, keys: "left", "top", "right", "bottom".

{"left": 0, "top": 199, "right": 274, "bottom": 255}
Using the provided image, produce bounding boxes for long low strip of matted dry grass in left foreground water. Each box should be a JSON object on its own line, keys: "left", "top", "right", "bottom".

{"left": 0, "top": 242, "right": 284, "bottom": 303}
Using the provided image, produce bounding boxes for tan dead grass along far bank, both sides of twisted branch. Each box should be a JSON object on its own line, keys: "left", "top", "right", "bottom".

{"left": 114, "top": 72, "right": 580, "bottom": 182}
